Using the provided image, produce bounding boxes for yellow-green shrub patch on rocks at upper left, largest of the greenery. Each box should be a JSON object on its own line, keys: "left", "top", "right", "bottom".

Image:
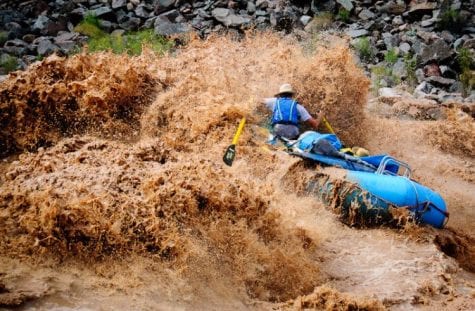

{"left": 74, "top": 14, "right": 173, "bottom": 55}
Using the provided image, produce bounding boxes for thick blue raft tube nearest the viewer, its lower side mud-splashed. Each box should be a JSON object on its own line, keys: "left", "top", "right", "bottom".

{"left": 306, "top": 171, "right": 449, "bottom": 228}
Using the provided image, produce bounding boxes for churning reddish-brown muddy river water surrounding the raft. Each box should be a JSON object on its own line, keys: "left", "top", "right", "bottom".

{"left": 0, "top": 33, "right": 475, "bottom": 310}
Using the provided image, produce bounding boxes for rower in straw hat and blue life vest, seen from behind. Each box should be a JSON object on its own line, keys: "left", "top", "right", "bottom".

{"left": 262, "top": 83, "right": 323, "bottom": 139}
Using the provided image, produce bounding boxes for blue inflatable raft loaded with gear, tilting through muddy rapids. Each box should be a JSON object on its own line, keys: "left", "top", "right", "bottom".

{"left": 278, "top": 131, "right": 449, "bottom": 228}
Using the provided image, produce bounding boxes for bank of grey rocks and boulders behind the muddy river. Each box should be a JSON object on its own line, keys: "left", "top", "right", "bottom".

{"left": 0, "top": 0, "right": 475, "bottom": 103}
